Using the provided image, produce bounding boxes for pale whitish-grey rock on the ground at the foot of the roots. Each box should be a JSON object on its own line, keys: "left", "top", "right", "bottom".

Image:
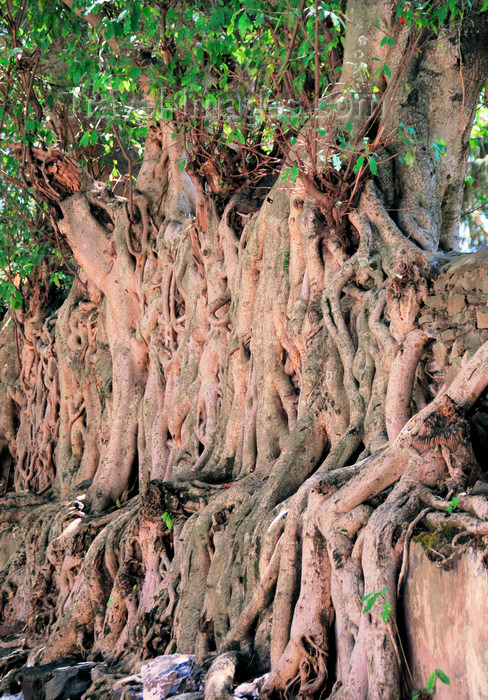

{"left": 141, "top": 654, "right": 201, "bottom": 700}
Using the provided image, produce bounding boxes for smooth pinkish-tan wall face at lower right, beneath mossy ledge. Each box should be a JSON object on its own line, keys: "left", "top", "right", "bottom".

{"left": 400, "top": 544, "right": 488, "bottom": 700}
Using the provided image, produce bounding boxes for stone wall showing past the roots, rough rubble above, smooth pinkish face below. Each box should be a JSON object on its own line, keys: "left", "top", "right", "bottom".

{"left": 399, "top": 248, "right": 488, "bottom": 700}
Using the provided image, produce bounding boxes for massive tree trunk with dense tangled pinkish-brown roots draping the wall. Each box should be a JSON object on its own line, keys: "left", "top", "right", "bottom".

{"left": 0, "top": 0, "right": 488, "bottom": 700}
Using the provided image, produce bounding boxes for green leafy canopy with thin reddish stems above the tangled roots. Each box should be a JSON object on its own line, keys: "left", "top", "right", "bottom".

{"left": 0, "top": 0, "right": 488, "bottom": 307}
